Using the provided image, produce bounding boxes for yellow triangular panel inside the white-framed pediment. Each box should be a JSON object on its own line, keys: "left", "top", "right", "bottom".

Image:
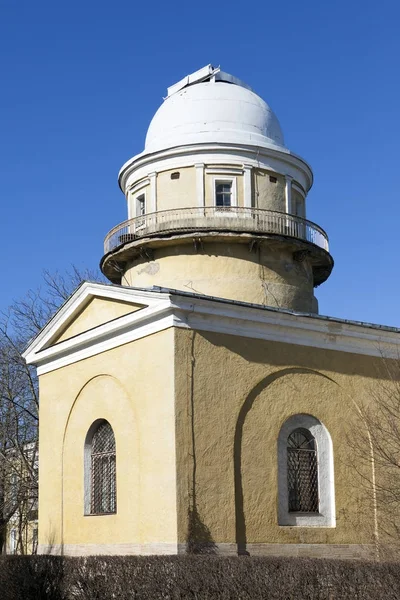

{"left": 47, "top": 296, "right": 145, "bottom": 347}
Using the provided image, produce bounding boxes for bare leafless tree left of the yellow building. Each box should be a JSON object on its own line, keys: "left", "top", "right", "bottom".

{"left": 0, "top": 267, "right": 103, "bottom": 553}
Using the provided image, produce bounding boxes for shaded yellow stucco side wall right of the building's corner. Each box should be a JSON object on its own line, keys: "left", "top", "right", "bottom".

{"left": 175, "top": 330, "right": 379, "bottom": 544}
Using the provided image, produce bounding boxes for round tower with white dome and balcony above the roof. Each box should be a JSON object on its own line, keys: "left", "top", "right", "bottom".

{"left": 100, "top": 65, "right": 333, "bottom": 313}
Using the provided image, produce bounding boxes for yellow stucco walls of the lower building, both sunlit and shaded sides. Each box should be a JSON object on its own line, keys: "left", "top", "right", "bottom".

{"left": 39, "top": 296, "right": 388, "bottom": 555}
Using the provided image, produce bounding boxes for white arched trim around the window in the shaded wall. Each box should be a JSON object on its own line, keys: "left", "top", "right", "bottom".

{"left": 278, "top": 414, "right": 336, "bottom": 527}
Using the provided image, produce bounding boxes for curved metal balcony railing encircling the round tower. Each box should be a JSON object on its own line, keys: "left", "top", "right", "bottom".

{"left": 104, "top": 206, "right": 329, "bottom": 254}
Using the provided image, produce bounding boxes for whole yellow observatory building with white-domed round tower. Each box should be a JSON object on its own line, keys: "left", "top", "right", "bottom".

{"left": 25, "top": 65, "right": 399, "bottom": 558}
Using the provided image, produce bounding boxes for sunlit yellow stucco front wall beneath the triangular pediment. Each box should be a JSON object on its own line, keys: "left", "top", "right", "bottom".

{"left": 39, "top": 330, "right": 177, "bottom": 554}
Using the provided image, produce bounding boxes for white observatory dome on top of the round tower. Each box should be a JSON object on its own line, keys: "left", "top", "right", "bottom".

{"left": 145, "top": 65, "right": 284, "bottom": 154}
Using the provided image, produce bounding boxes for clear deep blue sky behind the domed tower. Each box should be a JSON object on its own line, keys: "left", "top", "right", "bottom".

{"left": 0, "top": 0, "right": 400, "bottom": 326}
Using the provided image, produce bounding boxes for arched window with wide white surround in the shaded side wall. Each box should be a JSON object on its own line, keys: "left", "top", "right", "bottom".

{"left": 278, "top": 414, "right": 336, "bottom": 527}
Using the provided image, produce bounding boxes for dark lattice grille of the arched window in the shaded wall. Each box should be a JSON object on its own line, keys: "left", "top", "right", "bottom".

{"left": 287, "top": 429, "right": 318, "bottom": 513}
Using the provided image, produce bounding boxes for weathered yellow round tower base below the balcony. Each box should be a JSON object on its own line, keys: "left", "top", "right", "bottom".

{"left": 124, "top": 240, "right": 317, "bottom": 312}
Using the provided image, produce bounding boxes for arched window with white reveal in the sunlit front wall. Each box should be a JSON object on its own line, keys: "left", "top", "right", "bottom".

{"left": 85, "top": 419, "right": 117, "bottom": 515}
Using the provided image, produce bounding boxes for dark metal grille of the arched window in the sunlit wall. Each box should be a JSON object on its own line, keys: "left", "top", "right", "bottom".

{"left": 90, "top": 421, "right": 117, "bottom": 515}
